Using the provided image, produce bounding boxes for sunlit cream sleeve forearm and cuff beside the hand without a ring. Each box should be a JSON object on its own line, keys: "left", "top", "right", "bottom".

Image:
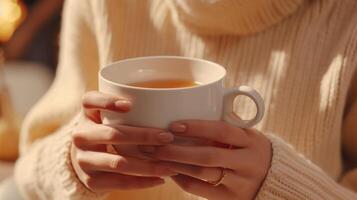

{"left": 15, "top": 115, "right": 105, "bottom": 200}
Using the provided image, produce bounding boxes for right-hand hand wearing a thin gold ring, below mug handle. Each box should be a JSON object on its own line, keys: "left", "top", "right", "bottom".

{"left": 143, "top": 120, "right": 272, "bottom": 200}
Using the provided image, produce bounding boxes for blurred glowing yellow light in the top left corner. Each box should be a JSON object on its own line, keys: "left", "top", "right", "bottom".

{"left": 0, "top": 0, "right": 26, "bottom": 42}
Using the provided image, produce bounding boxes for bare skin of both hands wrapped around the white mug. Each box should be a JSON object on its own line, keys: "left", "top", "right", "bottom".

{"left": 71, "top": 92, "right": 272, "bottom": 200}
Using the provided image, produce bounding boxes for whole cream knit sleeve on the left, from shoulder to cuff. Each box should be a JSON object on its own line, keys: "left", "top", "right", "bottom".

{"left": 15, "top": 0, "right": 101, "bottom": 200}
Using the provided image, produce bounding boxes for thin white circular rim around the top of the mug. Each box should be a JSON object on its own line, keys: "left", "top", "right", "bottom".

{"left": 98, "top": 56, "right": 227, "bottom": 91}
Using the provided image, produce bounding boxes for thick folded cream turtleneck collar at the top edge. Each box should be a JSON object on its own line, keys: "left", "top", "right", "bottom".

{"left": 167, "top": 0, "right": 305, "bottom": 35}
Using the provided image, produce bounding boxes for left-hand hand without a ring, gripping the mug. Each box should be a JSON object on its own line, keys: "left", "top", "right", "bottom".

{"left": 71, "top": 91, "right": 175, "bottom": 192}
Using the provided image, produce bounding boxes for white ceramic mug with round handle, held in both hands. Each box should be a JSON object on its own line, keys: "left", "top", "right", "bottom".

{"left": 99, "top": 56, "right": 264, "bottom": 129}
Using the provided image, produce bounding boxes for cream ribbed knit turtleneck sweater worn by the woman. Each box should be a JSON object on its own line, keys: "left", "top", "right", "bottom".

{"left": 15, "top": 0, "right": 357, "bottom": 200}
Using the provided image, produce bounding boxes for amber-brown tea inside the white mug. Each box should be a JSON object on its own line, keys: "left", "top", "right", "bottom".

{"left": 127, "top": 79, "right": 200, "bottom": 88}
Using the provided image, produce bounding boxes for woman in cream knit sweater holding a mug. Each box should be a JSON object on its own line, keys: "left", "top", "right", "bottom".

{"left": 16, "top": 0, "right": 357, "bottom": 200}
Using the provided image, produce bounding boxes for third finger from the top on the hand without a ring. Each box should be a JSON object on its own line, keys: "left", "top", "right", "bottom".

{"left": 76, "top": 151, "right": 177, "bottom": 176}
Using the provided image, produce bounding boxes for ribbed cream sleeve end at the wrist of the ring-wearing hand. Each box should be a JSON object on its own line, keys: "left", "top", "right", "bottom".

{"left": 256, "top": 134, "right": 356, "bottom": 200}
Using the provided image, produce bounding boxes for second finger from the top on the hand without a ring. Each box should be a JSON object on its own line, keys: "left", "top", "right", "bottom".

{"left": 72, "top": 123, "right": 174, "bottom": 149}
